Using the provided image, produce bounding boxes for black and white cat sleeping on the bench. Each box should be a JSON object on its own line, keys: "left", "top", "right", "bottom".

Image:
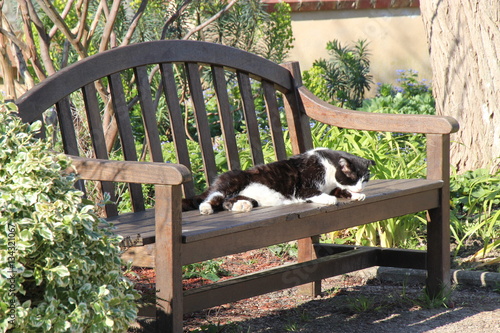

{"left": 183, "top": 148, "right": 375, "bottom": 215}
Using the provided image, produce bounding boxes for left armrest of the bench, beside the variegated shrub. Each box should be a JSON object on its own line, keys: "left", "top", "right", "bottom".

{"left": 69, "top": 156, "right": 191, "bottom": 185}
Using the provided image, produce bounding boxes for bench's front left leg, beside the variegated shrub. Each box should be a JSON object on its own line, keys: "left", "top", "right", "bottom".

{"left": 155, "top": 185, "right": 183, "bottom": 333}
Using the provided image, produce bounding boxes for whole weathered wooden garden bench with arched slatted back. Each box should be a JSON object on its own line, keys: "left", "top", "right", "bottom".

{"left": 17, "top": 41, "right": 458, "bottom": 332}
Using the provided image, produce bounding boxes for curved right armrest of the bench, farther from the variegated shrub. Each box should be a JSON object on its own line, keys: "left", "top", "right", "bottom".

{"left": 298, "top": 86, "right": 459, "bottom": 134}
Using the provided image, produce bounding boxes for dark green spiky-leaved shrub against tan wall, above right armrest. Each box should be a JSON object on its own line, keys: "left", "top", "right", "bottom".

{"left": 304, "top": 40, "right": 372, "bottom": 109}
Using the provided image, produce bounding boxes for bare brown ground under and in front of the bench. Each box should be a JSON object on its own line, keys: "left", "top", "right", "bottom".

{"left": 130, "top": 249, "right": 500, "bottom": 333}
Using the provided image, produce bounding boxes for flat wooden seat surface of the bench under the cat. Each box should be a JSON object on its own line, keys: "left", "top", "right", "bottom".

{"left": 109, "top": 179, "right": 442, "bottom": 244}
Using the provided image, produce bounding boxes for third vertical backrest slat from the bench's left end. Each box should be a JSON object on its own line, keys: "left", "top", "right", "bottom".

{"left": 109, "top": 73, "right": 144, "bottom": 212}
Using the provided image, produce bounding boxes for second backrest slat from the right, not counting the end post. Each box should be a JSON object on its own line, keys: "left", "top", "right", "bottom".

{"left": 237, "top": 72, "right": 264, "bottom": 165}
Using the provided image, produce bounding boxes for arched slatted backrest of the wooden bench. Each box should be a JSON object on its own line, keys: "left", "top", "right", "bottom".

{"left": 16, "top": 41, "right": 312, "bottom": 216}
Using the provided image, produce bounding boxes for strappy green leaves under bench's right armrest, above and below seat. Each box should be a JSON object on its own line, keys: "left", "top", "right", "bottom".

{"left": 311, "top": 123, "right": 426, "bottom": 248}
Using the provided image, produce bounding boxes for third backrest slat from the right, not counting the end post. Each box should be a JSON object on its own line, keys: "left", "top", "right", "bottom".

{"left": 212, "top": 66, "right": 241, "bottom": 170}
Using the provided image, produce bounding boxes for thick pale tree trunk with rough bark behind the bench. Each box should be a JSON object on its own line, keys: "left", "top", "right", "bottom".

{"left": 420, "top": 0, "right": 500, "bottom": 172}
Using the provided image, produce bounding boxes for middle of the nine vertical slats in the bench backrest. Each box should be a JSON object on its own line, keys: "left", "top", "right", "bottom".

{"left": 160, "top": 63, "right": 195, "bottom": 198}
